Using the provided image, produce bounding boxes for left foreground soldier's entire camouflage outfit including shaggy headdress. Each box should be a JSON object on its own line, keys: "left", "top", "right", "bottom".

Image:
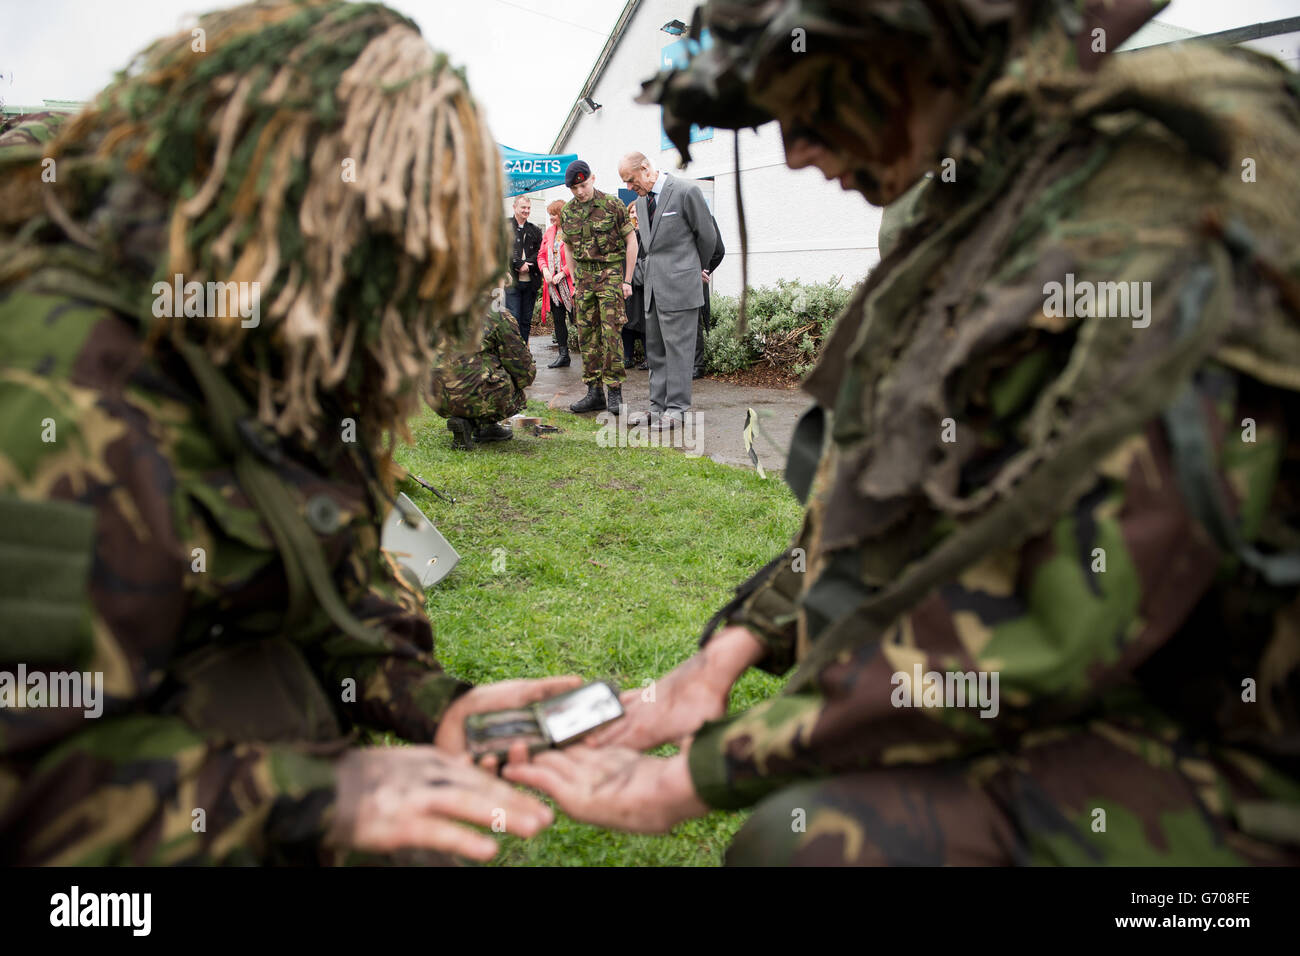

{"left": 0, "top": 3, "right": 506, "bottom": 864}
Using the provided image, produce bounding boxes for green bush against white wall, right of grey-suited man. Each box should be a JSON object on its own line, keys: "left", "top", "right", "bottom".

{"left": 705, "top": 278, "right": 853, "bottom": 378}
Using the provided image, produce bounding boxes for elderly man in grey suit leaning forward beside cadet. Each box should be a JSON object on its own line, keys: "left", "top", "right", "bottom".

{"left": 619, "top": 152, "right": 718, "bottom": 428}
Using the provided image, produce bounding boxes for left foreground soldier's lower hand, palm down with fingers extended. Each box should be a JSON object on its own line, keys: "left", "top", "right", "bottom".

{"left": 326, "top": 747, "right": 554, "bottom": 860}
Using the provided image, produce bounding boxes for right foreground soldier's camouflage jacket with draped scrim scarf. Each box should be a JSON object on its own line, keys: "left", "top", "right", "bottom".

{"left": 689, "top": 47, "right": 1300, "bottom": 827}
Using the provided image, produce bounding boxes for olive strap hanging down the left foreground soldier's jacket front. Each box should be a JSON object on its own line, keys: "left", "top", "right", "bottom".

{"left": 176, "top": 342, "right": 384, "bottom": 656}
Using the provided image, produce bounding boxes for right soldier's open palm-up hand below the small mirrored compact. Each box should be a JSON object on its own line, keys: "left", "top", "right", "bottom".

{"left": 502, "top": 747, "right": 709, "bottom": 834}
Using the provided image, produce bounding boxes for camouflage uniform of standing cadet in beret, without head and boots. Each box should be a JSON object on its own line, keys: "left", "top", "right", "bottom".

{"left": 560, "top": 190, "right": 632, "bottom": 386}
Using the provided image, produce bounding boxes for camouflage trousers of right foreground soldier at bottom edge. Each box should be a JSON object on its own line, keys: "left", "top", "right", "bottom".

{"left": 727, "top": 724, "right": 1300, "bottom": 866}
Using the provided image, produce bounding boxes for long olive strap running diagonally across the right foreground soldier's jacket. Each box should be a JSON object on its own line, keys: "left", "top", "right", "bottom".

{"left": 785, "top": 247, "right": 1231, "bottom": 693}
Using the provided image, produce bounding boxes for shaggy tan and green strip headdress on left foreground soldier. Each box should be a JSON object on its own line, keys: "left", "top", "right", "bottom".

{"left": 22, "top": 1, "right": 504, "bottom": 452}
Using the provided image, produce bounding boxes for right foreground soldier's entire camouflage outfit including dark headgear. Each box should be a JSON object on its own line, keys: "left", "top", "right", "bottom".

{"left": 646, "top": 0, "right": 1300, "bottom": 864}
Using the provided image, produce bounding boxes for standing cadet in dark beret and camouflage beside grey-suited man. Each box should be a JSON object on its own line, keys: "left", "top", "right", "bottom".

{"left": 560, "top": 160, "right": 637, "bottom": 415}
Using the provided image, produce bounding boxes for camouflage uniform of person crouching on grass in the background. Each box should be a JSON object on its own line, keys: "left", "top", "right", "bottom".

{"left": 430, "top": 308, "right": 537, "bottom": 425}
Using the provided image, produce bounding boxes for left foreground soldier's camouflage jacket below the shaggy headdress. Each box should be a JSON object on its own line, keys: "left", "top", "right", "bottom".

{"left": 0, "top": 283, "right": 467, "bottom": 864}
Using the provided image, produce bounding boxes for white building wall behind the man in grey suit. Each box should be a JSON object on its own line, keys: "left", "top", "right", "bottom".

{"left": 533, "top": 0, "right": 881, "bottom": 295}
